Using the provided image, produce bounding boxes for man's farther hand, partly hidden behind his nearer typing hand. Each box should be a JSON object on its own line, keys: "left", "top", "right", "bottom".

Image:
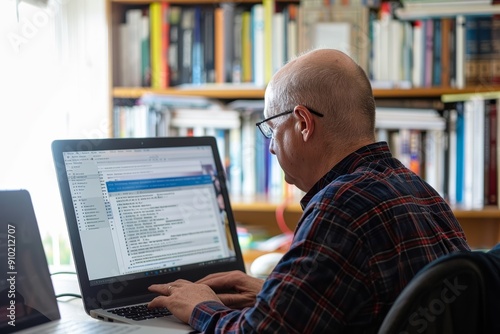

{"left": 196, "top": 270, "right": 264, "bottom": 309}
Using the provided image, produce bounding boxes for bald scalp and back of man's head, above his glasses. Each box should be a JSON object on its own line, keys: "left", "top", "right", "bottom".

{"left": 266, "top": 49, "right": 375, "bottom": 143}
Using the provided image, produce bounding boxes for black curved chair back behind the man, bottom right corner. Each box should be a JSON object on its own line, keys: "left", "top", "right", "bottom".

{"left": 378, "top": 244, "right": 500, "bottom": 334}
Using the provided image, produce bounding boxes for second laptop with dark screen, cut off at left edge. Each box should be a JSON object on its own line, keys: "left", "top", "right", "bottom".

{"left": 0, "top": 190, "right": 188, "bottom": 334}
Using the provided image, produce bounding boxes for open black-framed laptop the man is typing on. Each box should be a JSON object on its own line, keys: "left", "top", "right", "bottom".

{"left": 52, "top": 137, "right": 245, "bottom": 327}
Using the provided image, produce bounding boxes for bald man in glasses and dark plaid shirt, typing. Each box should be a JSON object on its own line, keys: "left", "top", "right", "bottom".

{"left": 146, "top": 49, "right": 469, "bottom": 333}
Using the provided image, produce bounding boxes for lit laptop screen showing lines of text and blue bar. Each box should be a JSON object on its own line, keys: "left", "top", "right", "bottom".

{"left": 64, "top": 146, "right": 235, "bottom": 284}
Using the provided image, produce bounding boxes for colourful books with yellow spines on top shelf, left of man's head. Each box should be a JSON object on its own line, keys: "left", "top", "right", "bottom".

{"left": 114, "top": 0, "right": 299, "bottom": 88}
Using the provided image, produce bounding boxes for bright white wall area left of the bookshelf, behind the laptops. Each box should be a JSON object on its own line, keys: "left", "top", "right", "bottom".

{"left": 0, "top": 0, "right": 109, "bottom": 266}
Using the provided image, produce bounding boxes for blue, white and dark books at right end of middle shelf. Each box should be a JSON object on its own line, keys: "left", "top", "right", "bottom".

{"left": 445, "top": 98, "right": 500, "bottom": 209}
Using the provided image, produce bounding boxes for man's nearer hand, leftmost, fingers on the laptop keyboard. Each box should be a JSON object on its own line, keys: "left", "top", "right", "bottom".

{"left": 148, "top": 280, "right": 221, "bottom": 323}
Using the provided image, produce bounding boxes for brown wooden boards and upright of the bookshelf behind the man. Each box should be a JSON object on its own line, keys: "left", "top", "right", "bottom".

{"left": 107, "top": 0, "right": 500, "bottom": 248}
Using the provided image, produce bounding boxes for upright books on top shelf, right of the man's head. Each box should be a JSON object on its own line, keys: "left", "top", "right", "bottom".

{"left": 371, "top": 3, "right": 500, "bottom": 88}
